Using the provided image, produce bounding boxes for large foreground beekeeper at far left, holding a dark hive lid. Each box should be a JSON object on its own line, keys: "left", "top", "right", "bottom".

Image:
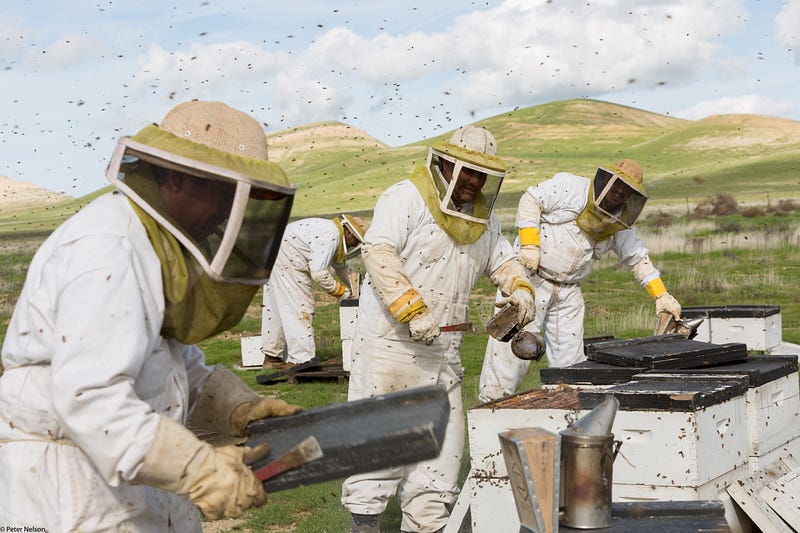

{"left": 0, "top": 101, "right": 299, "bottom": 532}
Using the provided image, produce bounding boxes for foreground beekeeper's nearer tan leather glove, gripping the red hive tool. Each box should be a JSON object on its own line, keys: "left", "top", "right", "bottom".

{"left": 131, "top": 416, "right": 269, "bottom": 520}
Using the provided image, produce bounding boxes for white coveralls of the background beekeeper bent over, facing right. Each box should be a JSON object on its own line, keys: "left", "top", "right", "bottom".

{"left": 261, "top": 218, "right": 348, "bottom": 364}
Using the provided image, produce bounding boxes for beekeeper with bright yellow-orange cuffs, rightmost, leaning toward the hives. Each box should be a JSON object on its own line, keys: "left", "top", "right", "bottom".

{"left": 479, "top": 159, "right": 681, "bottom": 402}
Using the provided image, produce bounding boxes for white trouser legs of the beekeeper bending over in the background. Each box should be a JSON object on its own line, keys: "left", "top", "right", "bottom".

{"left": 261, "top": 264, "right": 316, "bottom": 363}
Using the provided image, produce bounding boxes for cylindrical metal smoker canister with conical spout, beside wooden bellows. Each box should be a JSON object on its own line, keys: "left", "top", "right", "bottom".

{"left": 559, "top": 395, "right": 622, "bottom": 529}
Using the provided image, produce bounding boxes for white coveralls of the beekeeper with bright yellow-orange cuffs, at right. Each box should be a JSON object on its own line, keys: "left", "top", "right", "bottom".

{"left": 478, "top": 172, "right": 658, "bottom": 402}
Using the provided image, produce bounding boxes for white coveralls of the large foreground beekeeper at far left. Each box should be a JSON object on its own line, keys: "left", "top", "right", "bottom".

{"left": 0, "top": 193, "right": 211, "bottom": 533}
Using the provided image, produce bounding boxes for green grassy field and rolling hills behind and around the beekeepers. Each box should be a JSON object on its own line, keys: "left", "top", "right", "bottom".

{"left": 0, "top": 100, "right": 800, "bottom": 533}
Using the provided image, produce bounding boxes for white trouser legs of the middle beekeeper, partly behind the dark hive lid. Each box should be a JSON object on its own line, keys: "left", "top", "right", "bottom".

{"left": 342, "top": 338, "right": 465, "bottom": 532}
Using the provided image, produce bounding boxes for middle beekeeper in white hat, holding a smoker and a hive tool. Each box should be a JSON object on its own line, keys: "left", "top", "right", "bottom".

{"left": 342, "top": 126, "right": 533, "bottom": 532}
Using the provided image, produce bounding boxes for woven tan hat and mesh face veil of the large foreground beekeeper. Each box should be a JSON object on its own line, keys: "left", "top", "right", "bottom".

{"left": 106, "top": 102, "right": 295, "bottom": 285}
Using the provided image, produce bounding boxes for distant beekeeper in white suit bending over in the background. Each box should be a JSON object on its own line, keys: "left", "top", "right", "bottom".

{"left": 261, "top": 214, "right": 368, "bottom": 370}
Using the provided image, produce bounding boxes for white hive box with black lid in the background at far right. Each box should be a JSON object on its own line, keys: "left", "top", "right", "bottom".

{"left": 681, "top": 305, "right": 783, "bottom": 351}
